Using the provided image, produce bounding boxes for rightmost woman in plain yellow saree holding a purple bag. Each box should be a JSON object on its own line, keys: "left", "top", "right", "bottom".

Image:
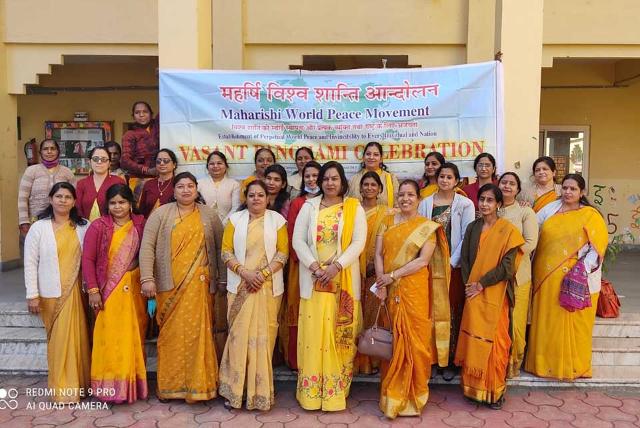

{"left": 525, "top": 174, "right": 608, "bottom": 380}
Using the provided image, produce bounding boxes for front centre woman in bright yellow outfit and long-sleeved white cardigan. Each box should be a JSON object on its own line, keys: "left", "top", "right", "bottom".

{"left": 293, "top": 161, "right": 367, "bottom": 411}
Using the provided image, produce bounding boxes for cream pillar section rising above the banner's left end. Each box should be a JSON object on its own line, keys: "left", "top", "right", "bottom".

{"left": 158, "top": 0, "right": 212, "bottom": 69}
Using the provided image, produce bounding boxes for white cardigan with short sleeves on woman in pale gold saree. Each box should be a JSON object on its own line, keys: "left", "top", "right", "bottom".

{"left": 227, "top": 209, "right": 287, "bottom": 296}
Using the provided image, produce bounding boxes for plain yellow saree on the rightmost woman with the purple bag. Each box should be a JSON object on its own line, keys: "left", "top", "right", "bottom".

{"left": 525, "top": 207, "right": 608, "bottom": 380}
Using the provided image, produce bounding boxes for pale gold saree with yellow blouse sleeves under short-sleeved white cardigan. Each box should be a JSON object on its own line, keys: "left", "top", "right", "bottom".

{"left": 220, "top": 217, "right": 289, "bottom": 411}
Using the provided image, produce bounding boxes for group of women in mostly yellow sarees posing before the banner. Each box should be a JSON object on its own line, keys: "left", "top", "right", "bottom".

{"left": 25, "top": 130, "right": 607, "bottom": 418}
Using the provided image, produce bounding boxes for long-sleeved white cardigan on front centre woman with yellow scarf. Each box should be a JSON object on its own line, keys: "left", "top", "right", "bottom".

{"left": 292, "top": 198, "right": 367, "bottom": 300}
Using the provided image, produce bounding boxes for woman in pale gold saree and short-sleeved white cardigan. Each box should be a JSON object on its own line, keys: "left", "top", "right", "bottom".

{"left": 219, "top": 180, "right": 289, "bottom": 411}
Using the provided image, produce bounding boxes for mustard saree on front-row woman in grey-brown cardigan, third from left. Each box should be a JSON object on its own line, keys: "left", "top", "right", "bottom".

{"left": 156, "top": 209, "right": 218, "bottom": 401}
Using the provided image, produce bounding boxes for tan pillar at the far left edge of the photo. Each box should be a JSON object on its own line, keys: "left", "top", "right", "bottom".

{"left": 0, "top": 1, "right": 20, "bottom": 270}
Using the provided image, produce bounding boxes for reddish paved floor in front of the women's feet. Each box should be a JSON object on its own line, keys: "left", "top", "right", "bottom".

{"left": 0, "top": 376, "right": 640, "bottom": 428}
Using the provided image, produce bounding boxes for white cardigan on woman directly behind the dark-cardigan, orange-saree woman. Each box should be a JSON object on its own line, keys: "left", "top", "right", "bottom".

{"left": 418, "top": 193, "right": 476, "bottom": 268}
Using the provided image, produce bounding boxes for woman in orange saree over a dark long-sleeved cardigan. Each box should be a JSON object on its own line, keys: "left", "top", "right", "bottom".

{"left": 455, "top": 183, "right": 524, "bottom": 409}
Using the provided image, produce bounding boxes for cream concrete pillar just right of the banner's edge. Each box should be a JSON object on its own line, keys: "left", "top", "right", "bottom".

{"left": 496, "top": 0, "right": 544, "bottom": 174}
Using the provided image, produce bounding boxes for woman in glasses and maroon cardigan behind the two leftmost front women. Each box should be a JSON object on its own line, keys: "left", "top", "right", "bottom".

{"left": 76, "top": 147, "right": 124, "bottom": 221}
